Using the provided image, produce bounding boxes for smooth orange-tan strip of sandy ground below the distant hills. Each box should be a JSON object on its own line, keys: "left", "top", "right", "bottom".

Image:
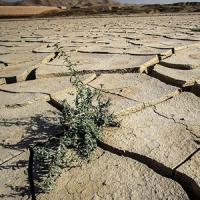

{"left": 0, "top": 6, "right": 59, "bottom": 16}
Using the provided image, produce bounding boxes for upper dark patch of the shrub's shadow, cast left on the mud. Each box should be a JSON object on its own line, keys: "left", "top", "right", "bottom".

{"left": 0, "top": 111, "right": 62, "bottom": 150}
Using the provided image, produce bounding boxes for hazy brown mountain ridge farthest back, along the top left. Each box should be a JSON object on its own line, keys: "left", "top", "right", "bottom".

{"left": 0, "top": 0, "right": 123, "bottom": 7}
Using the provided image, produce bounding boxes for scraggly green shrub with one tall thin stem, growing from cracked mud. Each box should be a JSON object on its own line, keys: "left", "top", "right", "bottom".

{"left": 34, "top": 45, "right": 120, "bottom": 192}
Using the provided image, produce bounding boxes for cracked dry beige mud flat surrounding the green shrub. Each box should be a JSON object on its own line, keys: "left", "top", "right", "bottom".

{"left": 0, "top": 13, "right": 200, "bottom": 200}
